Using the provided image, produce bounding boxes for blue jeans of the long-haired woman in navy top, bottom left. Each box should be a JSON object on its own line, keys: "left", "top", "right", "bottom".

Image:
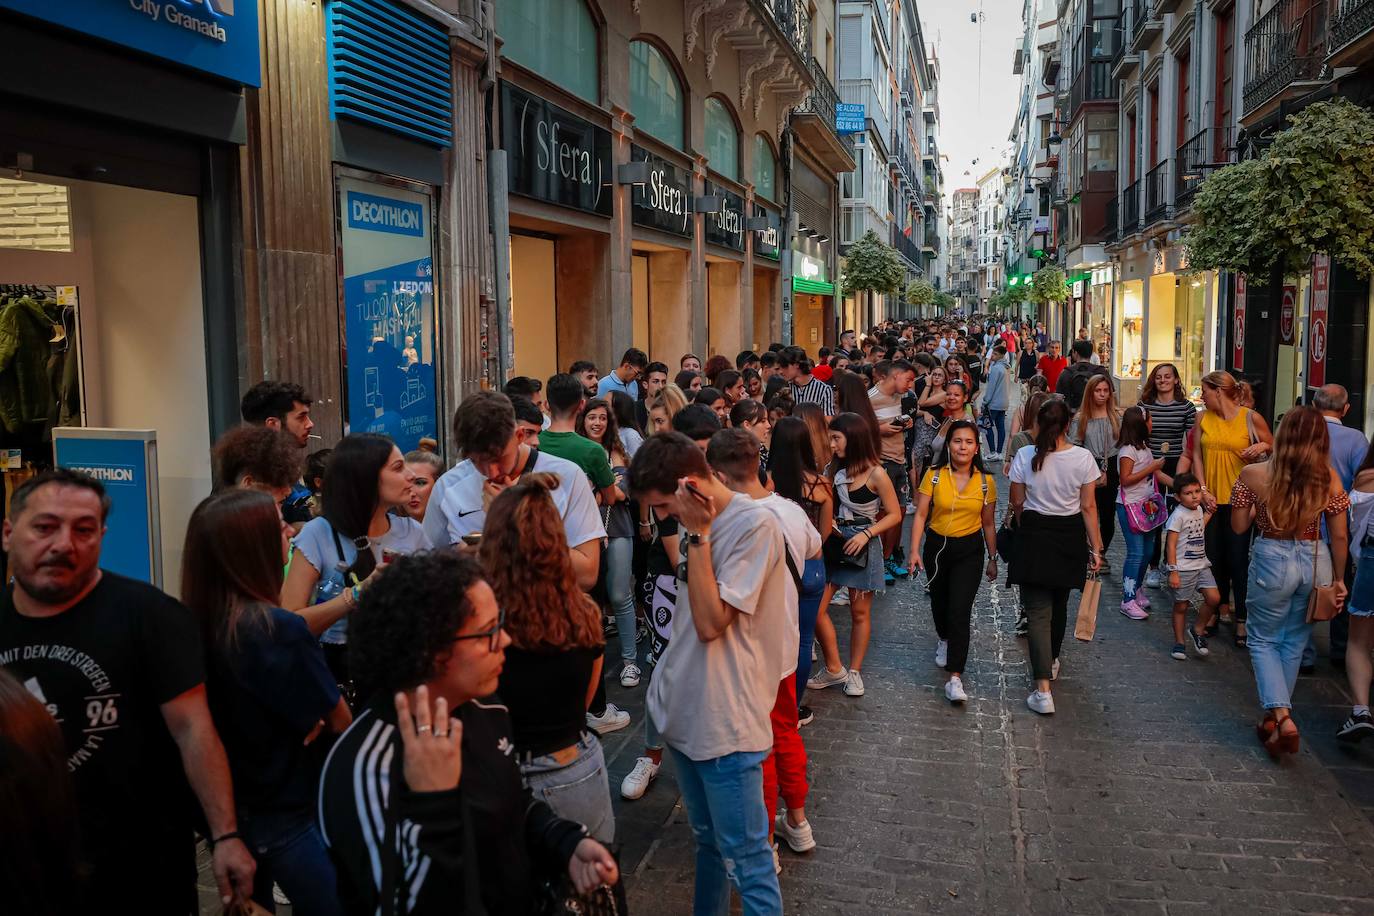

{"left": 240, "top": 810, "right": 344, "bottom": 916}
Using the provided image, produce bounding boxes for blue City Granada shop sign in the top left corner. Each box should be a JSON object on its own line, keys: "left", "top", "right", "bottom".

{"left": 0, "top": 0, "right": 262, "bottom": 91}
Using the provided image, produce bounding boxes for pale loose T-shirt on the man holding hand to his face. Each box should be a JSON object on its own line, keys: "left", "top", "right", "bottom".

{"left": 647, "top": 493, "right": 798, "bottom": 761}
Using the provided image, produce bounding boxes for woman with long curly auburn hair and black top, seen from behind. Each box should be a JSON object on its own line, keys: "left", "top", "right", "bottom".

{"left": 478, "top": 474, "right": 618, "bottom": 843}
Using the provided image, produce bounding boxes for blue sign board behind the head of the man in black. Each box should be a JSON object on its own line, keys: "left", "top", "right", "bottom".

{"left": 52, "top": 427, "right": 162, "bottom": 586}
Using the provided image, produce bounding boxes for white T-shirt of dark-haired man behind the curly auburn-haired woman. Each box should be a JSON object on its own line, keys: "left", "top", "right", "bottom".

{"left": 425, "top": 452, "right": 606, "bottom": 547}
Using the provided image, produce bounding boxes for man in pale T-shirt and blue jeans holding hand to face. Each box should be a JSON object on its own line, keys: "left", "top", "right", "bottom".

{"left": 629, "top": 433, "right": 797, "bottom": 916}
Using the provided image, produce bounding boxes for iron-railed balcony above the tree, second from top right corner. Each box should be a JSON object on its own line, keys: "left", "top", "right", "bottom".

{"left": 1242, "top": 0, "right": 1329, "bottom": 121}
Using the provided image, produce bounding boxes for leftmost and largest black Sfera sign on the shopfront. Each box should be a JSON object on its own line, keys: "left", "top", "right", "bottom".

{"left": 502, "top": 82, "right": 611, "bottom": 217}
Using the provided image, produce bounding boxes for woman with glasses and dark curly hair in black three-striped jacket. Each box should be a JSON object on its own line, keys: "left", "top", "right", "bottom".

{"left": 319, "top": 549, "right": 620, "bottom": 916}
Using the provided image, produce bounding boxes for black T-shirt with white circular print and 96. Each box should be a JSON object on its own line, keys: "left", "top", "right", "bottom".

{"left": 0, "top": 571, "right": 205, "bottom": 912}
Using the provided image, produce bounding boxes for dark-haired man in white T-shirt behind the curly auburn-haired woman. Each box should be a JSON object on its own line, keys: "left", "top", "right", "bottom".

{"left": 425, "top": 391, "right": 606, "bottom": 589}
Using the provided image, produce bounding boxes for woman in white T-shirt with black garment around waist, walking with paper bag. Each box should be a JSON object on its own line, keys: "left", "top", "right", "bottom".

{"left": 1007, "top": 398, "right": 1102, "bottom": 715}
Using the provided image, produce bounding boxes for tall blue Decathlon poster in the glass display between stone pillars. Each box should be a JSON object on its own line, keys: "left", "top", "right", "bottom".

{"left": 337, "top": 174, "right": 438, "bottom": 452}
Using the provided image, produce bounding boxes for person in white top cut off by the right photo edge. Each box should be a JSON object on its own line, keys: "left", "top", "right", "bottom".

{"left": 1336, "top": 448, "right": 1374, "bottom": 742}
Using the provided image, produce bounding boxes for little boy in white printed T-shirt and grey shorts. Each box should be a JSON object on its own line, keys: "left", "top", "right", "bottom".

{"left": 1161, "top": 472, "right": 1221, "bottom": 662}
